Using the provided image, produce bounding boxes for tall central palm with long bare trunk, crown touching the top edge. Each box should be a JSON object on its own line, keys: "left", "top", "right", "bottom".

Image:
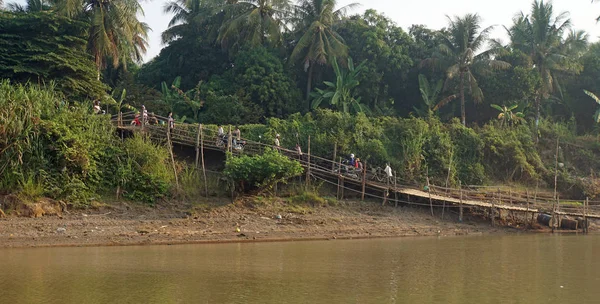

{"left": 290, "top": 0, "right": 358, "bottom": 109}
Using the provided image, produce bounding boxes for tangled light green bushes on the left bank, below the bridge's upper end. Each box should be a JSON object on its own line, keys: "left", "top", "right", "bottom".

{"left": 0, "top": 81, "right": 172, "bottom": 205}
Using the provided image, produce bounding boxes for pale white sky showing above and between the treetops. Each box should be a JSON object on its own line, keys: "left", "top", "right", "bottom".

{"left": 5, "top": 0, "right": 600, "bottom": 61}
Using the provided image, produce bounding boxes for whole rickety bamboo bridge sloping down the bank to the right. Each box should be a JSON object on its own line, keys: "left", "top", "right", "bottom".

{"left": 112, "top": 112, "right": 600, "bottom": 231}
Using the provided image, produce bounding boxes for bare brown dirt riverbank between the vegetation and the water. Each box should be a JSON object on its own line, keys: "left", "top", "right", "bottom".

{"left": 0, "top": 199, "right": 540, "bottom": 247}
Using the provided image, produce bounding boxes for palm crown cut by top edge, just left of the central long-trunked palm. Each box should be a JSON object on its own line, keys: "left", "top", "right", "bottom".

{"left": 217, "top": 0, "right": 292, "bottom": 48}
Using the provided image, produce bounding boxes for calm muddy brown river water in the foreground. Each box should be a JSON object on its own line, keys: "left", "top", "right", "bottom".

{"left": 0, "top": 235, "right": 600, "bottom": 303}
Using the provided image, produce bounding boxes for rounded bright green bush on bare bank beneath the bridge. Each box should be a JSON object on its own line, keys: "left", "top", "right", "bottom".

{"left": 224, "top": 149, "right": 303, "bottom": 192}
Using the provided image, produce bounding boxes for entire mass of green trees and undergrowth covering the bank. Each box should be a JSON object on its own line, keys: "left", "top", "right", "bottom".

{"left": 0, "top": 0, "right": 600, "bottom": 203}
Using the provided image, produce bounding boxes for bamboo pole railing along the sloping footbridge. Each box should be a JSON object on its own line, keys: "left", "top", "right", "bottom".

{"left": 113, "top": 112, "right": 600, "bottom": 214}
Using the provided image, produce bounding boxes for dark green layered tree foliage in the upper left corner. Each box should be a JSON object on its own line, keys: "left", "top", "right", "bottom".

{"left": 0, "top": 11, "right": 104, "bottom": 98}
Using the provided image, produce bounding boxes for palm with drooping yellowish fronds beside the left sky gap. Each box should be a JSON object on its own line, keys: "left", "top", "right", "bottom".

{"left": 55, "top": 0, "right": 150, "bottom": 78}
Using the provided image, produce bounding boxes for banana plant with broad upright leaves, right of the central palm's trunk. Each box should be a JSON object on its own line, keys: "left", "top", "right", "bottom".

{"left": 311, "top": 58, "right": 370, "bottom": 113}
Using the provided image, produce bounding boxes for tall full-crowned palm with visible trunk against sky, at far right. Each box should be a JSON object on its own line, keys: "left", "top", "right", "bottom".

{"left": 507, "top": 0, "right": 587, "bottom": 126}
